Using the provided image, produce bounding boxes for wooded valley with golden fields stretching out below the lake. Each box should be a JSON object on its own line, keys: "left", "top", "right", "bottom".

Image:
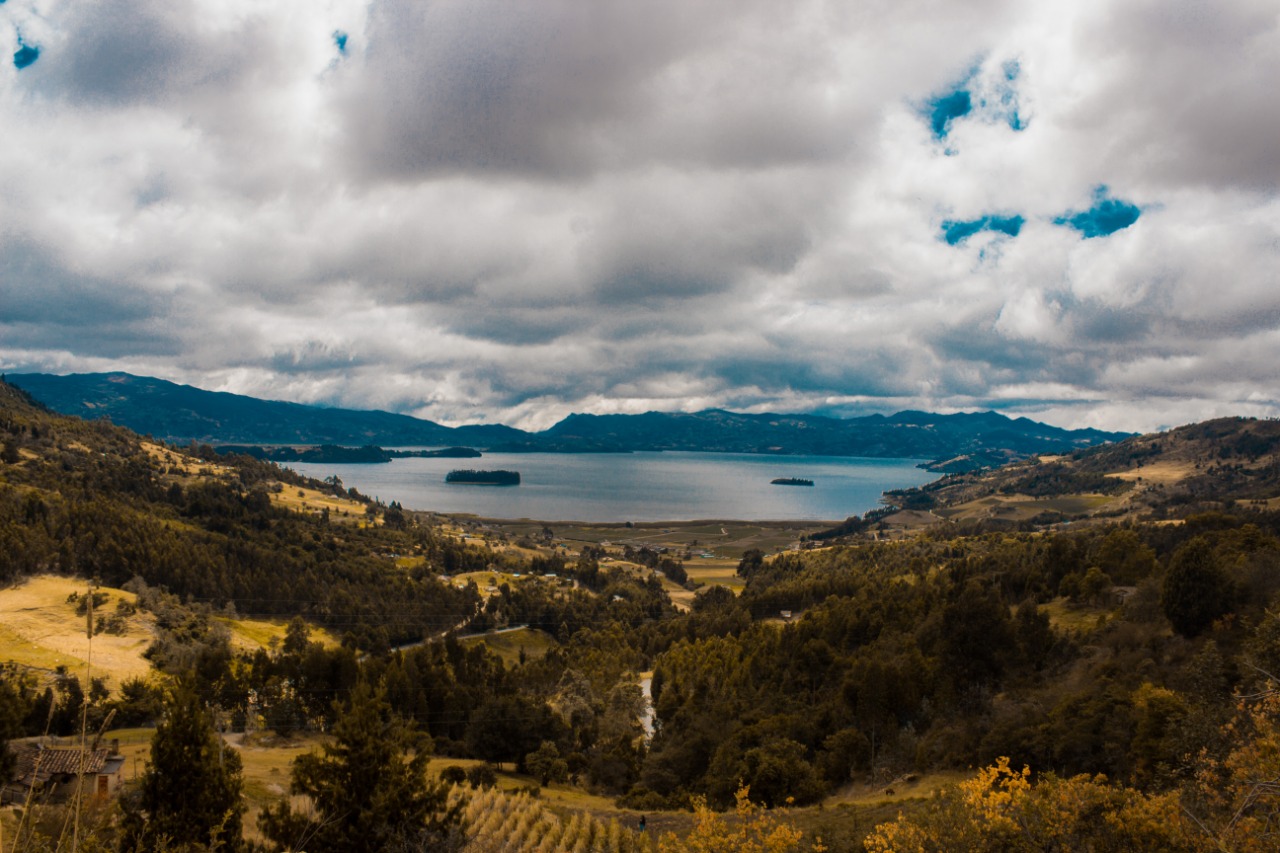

{"left": 0, "top": 384, "right": 1280, "bottom": 850}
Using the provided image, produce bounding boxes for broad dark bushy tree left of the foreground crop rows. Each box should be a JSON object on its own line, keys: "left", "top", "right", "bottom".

{"left": 259, "top": 683, "right": 461, "bottom": 853}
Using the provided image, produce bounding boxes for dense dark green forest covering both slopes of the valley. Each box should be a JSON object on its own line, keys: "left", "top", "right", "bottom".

{"left": 0, "top": 384, "right": 1280, "bottom": 850}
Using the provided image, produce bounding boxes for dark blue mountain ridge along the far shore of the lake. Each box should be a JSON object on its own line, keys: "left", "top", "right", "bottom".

{"left": 6, "top": 373, "right": 1129, "bottom": 470}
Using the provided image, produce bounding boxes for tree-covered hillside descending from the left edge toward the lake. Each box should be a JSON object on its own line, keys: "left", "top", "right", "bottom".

{"left": 0, "top": 382, "right": 474, "bottom": 646}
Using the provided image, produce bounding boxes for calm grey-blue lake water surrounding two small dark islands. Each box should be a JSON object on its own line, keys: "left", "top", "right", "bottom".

{"left": 288, "top": 452, "right": 937, "bottom": 521}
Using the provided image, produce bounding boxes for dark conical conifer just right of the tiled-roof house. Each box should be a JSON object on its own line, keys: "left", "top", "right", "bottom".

{"left": 122, "top": 681, "right": 244, "bottom": 850}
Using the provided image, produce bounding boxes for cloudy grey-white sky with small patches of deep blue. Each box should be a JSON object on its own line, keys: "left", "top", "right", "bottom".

{"left": 0, "top": 0, "right": 1280, "bottom": 430}
